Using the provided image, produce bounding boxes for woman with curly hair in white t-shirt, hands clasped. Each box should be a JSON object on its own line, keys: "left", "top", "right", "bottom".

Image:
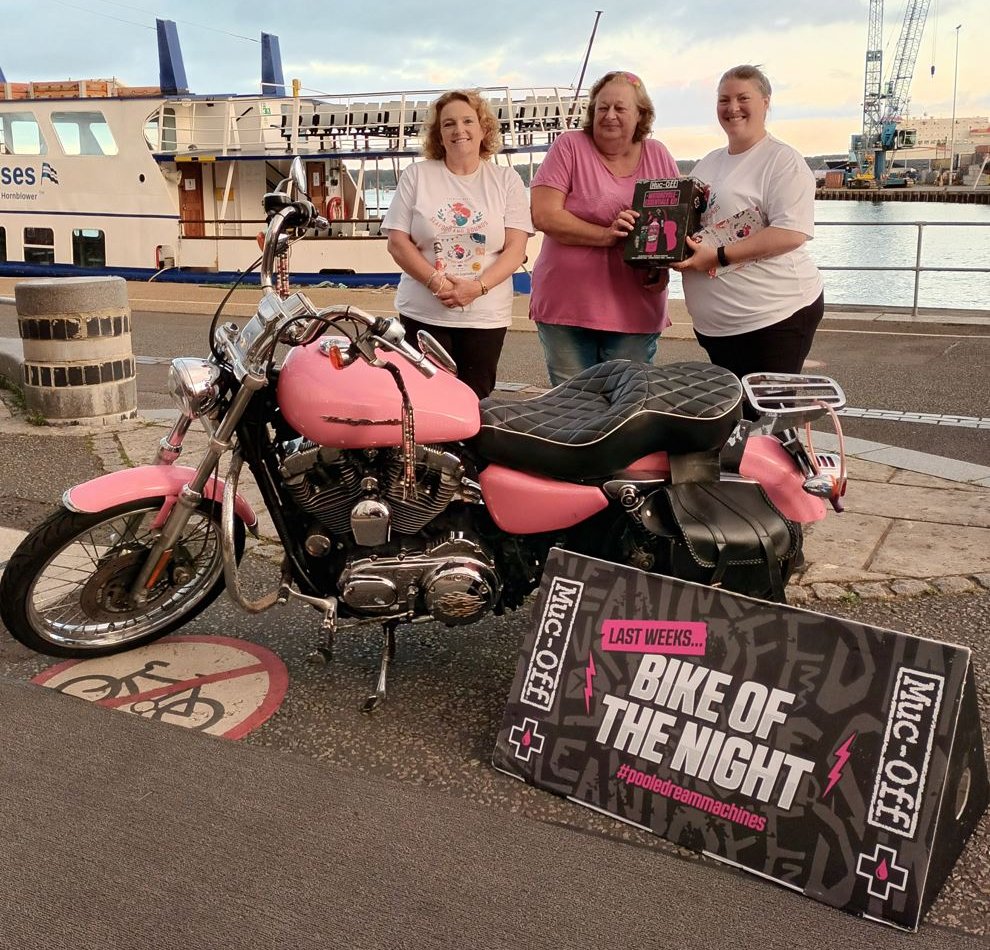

{"left": 382, "top": 90, "right": 533, "bottom": 398}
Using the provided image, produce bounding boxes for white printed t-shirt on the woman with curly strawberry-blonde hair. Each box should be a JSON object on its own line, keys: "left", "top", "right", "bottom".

{"left": 382, "top": 160, "right": 533, "bottom": 329}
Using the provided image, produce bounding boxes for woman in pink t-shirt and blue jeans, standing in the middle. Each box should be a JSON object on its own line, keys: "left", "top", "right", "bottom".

{"left": 529, "top": 71, "right": 678, "bottom": 386}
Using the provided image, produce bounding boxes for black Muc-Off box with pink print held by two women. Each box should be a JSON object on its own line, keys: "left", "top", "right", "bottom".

{"left": 623, "top": 178, "right": 707, "bottom": 267}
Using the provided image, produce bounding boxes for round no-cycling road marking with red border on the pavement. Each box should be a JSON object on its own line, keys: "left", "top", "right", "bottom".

{"left": 32, "top": 635, "right": 289, "bottom": 739}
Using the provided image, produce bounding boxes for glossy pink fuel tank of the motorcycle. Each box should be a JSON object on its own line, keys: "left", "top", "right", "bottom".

{"left": 277, "top": 338, "right": 480, "bottom": 449}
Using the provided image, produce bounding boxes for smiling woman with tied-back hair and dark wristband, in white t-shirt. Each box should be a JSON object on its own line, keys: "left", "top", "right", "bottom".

{"left": 673, "top": 66, "right": 825, "bottom": 377}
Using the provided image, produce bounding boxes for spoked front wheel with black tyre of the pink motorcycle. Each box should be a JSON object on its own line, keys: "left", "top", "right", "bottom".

{"left": 0, "top": 498, "right": 244, "bottom": 657}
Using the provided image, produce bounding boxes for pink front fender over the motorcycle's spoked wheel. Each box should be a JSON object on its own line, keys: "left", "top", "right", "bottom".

{"left": 62, "top": 465, "right": 258, "bottom": 534}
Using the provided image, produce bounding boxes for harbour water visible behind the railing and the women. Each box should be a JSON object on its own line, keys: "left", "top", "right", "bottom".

{"left": 368, "top": 190, "right": 990, "bottom": 310}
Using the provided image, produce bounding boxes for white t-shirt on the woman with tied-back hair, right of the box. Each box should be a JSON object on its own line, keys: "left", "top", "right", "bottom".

{"left": 682, "top": 135, "right": 822, "bottom": 336}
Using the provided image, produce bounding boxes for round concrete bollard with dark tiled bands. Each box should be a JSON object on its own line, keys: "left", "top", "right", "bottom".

{"left": 14, "top": 277, "right": 137, "bottom": 425}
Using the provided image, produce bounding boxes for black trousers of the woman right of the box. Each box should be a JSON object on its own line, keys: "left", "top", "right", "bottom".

{"left": 694, "top": 293, "right": 825, "bottom": 378}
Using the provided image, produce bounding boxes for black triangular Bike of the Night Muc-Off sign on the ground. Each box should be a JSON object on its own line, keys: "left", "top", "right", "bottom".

{"left": 495, "top": 550, "right": 988, "bottom": 929}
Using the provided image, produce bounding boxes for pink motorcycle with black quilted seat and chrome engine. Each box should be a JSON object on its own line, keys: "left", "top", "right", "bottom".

{"left": 0, "top": 161, "right": 845, "bottom": 708}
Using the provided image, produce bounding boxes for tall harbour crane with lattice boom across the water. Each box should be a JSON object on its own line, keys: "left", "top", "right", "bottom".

{"left": 849, "top": 0, "right": 931, "bottom": 187}
